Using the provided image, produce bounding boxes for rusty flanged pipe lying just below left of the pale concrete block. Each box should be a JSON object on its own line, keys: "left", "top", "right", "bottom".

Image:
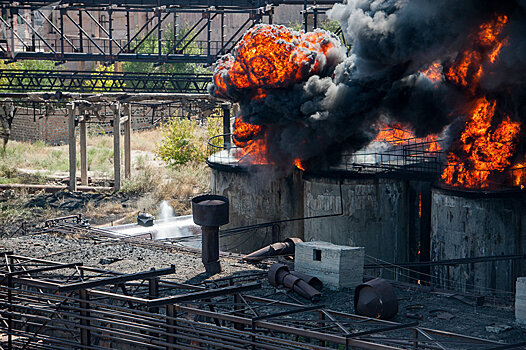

{"left": 268, "top": 263, "right": 321, "bottom": 302}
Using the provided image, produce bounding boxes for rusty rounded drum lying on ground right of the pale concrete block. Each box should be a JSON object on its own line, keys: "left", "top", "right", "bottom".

{"left": 354, "top": 278, "right": 398, "bottom": 320}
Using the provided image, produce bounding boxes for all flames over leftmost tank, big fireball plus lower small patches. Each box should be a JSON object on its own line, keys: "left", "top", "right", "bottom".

{"left": 213, "top": 24, "right": 343, "bottom": 170}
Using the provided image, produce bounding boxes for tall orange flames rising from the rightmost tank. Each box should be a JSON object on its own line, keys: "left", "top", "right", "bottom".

{"left": 442, "top": 16, "right": 523, "bottom": 189}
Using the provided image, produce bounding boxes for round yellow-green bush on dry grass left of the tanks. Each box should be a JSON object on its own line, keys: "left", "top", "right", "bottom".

{"left": 156, "top": 119, "right": 206, "bottom": 166}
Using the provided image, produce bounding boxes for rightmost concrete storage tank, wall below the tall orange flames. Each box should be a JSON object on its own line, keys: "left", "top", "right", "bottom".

{"left": 431, "top": 188, "right": 526, "bottom": 295}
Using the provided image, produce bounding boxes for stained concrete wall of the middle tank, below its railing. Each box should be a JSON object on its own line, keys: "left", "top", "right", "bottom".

{"left": 303, "top": 174, "right": 430, "bottom": 278}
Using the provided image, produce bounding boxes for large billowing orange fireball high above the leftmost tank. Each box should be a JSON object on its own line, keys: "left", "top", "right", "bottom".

{"left": 214, "top": 24, "right": 342, "bottom": 98}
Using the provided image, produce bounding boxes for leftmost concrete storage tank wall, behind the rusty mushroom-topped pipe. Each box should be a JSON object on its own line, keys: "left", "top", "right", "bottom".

{"left": 209, "top": 162, "right": 303, "bottom": 253}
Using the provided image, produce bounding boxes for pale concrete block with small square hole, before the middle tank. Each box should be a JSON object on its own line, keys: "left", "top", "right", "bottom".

{"left": 294, "top": 241, "right": 365, "bottom": 290}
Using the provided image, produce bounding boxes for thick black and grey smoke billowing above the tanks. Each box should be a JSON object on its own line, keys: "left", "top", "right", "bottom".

{"left": 209, "top": 0, "right": 526, "bottom": 170}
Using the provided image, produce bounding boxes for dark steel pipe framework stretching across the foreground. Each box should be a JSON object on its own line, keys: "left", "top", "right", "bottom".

{"left": 0, "top": 247, "right": 526, "bottom": 350}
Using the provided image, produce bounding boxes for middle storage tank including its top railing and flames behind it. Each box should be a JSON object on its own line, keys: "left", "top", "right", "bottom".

{"left": 303, "top": 124, "right": 441, "bottom": 277}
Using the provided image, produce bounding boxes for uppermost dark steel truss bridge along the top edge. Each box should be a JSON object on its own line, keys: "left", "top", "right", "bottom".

{"left": 0, "top": 0, "right": 339, "bottom": 65}
